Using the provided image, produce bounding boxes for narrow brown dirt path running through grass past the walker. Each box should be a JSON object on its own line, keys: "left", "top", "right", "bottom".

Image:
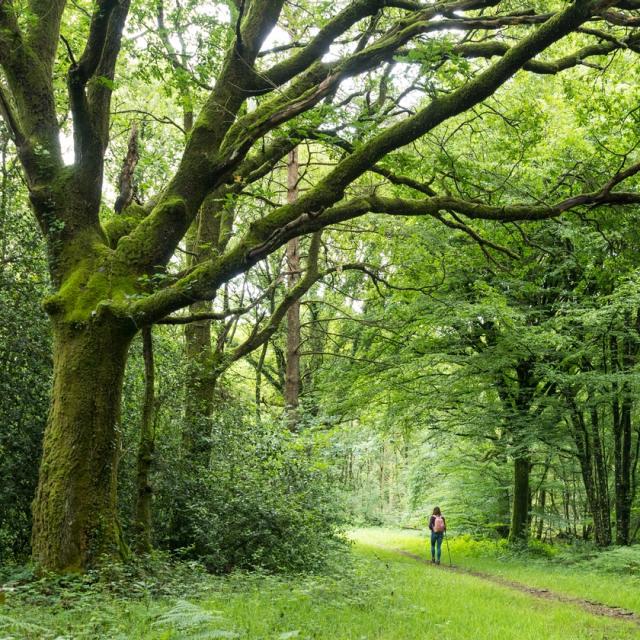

{"left": 373, "top": 545, "right": 640, "bottom": 626}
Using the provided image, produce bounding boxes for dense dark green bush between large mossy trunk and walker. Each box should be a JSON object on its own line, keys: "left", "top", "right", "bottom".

{"left": 155, "top": 407, "right": 344, "bottom": 572}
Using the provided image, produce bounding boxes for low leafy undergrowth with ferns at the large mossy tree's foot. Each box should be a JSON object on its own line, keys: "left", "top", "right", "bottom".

{"left": 0, "top": 553, "right": 364, "bottom": 640}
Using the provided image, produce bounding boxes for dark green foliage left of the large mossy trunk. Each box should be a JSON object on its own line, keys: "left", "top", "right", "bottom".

{"left": 0, "top": 128, "right": 51, "bottom": 564}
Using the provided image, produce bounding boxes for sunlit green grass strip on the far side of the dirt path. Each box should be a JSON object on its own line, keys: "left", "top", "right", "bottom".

{"left": 352, "top": 528, "right": 640, "bottom": 616}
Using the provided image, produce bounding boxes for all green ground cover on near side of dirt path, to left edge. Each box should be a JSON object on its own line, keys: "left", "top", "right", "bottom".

{"left": 0, "top": 530, "right": 640, "bottom": 640}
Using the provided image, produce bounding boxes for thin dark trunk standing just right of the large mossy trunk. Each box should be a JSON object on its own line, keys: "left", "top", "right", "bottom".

{"left": 133, "top": 327, "right": 155, "bottom": 553}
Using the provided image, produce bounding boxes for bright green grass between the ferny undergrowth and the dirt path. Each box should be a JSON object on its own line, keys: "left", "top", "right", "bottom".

{"left": 198, "top": 542, "right": 640, "bottom": 640}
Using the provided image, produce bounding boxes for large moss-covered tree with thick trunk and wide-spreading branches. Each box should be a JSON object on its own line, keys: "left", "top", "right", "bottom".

{"left": 0, "top": 0, "right": 640, "bottom": 570}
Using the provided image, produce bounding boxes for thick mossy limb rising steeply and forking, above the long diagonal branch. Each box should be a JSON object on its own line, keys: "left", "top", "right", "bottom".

{"left": 116, "top": 0, "right": 520, "bottom": 270}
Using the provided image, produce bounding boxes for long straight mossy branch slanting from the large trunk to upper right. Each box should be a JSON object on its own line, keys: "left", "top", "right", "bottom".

{"left": 119, "top": 0, "right": 609, "bottom": 323}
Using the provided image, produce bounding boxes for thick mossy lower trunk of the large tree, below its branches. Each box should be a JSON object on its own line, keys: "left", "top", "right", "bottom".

{"left": 32, "top": 319, "right": 135, "bottom": 571}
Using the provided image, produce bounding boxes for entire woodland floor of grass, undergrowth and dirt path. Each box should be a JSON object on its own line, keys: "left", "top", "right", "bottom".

{"left": 0, "top": 529, "right": 640, "bottom": 640}
